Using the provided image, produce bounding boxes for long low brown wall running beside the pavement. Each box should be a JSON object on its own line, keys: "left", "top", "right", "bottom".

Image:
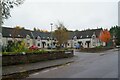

{"left": 2, "top": 50, "right": 74, "bottom": 66}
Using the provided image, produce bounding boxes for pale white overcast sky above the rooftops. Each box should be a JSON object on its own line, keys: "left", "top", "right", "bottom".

{"left": 4, "top": 0, "right": 118, "bottom": 31}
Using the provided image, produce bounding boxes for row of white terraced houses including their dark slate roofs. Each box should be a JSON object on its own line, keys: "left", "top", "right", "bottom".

{"left": 0, "top": 27, "right": 105, "bottom": 48}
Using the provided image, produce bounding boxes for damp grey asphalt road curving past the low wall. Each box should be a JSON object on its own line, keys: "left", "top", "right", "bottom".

{"left": 27, "top": 50, "right": 118, "bottom": 78}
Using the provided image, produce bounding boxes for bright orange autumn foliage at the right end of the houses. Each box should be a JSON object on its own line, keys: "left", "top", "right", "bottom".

{"left": 99, "top": 29, "right": 111, "bottom": 43}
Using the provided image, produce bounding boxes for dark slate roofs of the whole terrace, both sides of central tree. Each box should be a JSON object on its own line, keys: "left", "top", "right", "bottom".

{"left": 2, "top": 27, "right": 102, "bottom": 39}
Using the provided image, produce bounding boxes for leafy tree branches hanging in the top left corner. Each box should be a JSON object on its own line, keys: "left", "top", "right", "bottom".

{"left": 0, "top": 0, "right": 24, "bottom": 32}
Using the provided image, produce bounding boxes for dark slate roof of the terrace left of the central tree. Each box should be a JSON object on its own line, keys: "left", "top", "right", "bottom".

{"left": 2, "top": 27, "right": 50, "bottom": 39}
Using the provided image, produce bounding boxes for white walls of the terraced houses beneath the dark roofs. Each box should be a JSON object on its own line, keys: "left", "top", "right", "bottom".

{"left": 2, "top": 37, "right": 105, "bottom": 48}
